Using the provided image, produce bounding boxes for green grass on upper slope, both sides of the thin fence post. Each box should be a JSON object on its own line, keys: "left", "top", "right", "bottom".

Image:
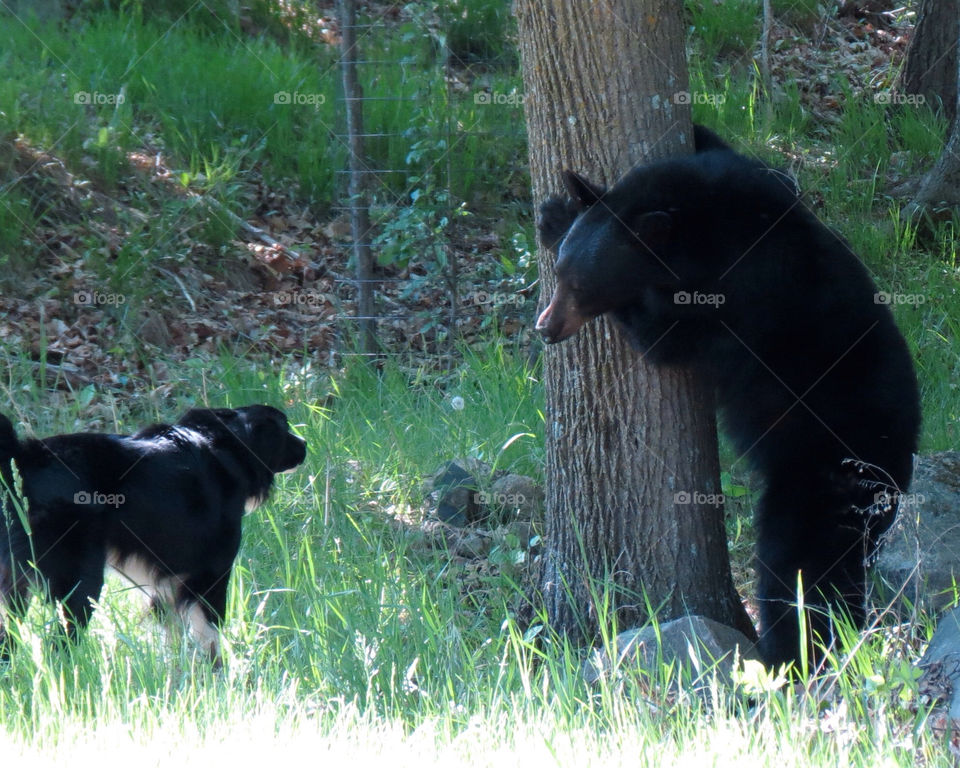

{"left": 0, "top": 4, "right": 523, "bottom": 207}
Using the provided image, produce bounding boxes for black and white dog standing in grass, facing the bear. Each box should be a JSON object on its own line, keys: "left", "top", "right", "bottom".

{"left": 0, "top": 405, "right": 306, "bottom": 661}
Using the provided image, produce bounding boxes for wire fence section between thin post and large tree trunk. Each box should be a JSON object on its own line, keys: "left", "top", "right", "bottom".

{"left": 335, "top": 0, "right": 535, "bottom": 356}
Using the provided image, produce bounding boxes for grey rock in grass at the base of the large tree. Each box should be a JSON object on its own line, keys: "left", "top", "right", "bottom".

{"left": 583, "top": 616, "right": 760, "bottom": 691}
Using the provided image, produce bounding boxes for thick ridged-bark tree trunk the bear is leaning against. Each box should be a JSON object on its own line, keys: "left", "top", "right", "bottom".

{"left": 516, "top": 0, "right": 755, "bottom": 637}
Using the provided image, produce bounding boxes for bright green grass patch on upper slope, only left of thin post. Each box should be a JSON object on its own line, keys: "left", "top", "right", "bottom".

{"left": 0, "top": 14, "right": 344, "bottom": 197}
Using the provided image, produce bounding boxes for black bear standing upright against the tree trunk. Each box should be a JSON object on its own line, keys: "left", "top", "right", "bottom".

{"left": 536, "top": 126, "right": 920, "bottom": 664}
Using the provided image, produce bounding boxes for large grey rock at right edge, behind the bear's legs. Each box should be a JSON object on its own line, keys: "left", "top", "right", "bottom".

{"left": 876, "top": 451, "right": 960, "bottom": 611}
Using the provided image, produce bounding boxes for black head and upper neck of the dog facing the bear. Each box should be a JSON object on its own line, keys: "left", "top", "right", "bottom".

{"left": 177, "top": 405, "right": 307, "bottom": 478}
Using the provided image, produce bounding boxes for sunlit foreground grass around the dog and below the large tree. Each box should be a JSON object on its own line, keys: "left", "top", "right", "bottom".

{"left": 0, "top": 345, "right": 938, "bottom": 768}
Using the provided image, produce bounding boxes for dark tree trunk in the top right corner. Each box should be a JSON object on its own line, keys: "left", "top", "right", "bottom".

{"left": 900, "top": 0, "right": 960, "bottom": 123}
